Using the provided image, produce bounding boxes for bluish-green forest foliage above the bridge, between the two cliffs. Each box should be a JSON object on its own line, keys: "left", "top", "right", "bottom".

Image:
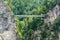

{"left": 6, "top": 0, "right": 56, "bottom": 15}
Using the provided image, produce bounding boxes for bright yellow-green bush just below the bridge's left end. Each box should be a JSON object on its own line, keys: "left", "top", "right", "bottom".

{"left": 16, "top": 21, "right": 25, "bottom": 37}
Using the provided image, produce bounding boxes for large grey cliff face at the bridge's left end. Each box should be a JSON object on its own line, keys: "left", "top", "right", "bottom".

{"left": 0, "top": 2, "right": 16, "bottom": 40}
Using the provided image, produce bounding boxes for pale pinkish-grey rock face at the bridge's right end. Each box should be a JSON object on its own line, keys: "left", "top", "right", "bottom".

{"left": 45, "top": 5, "right": 60, "bottom": 23}
